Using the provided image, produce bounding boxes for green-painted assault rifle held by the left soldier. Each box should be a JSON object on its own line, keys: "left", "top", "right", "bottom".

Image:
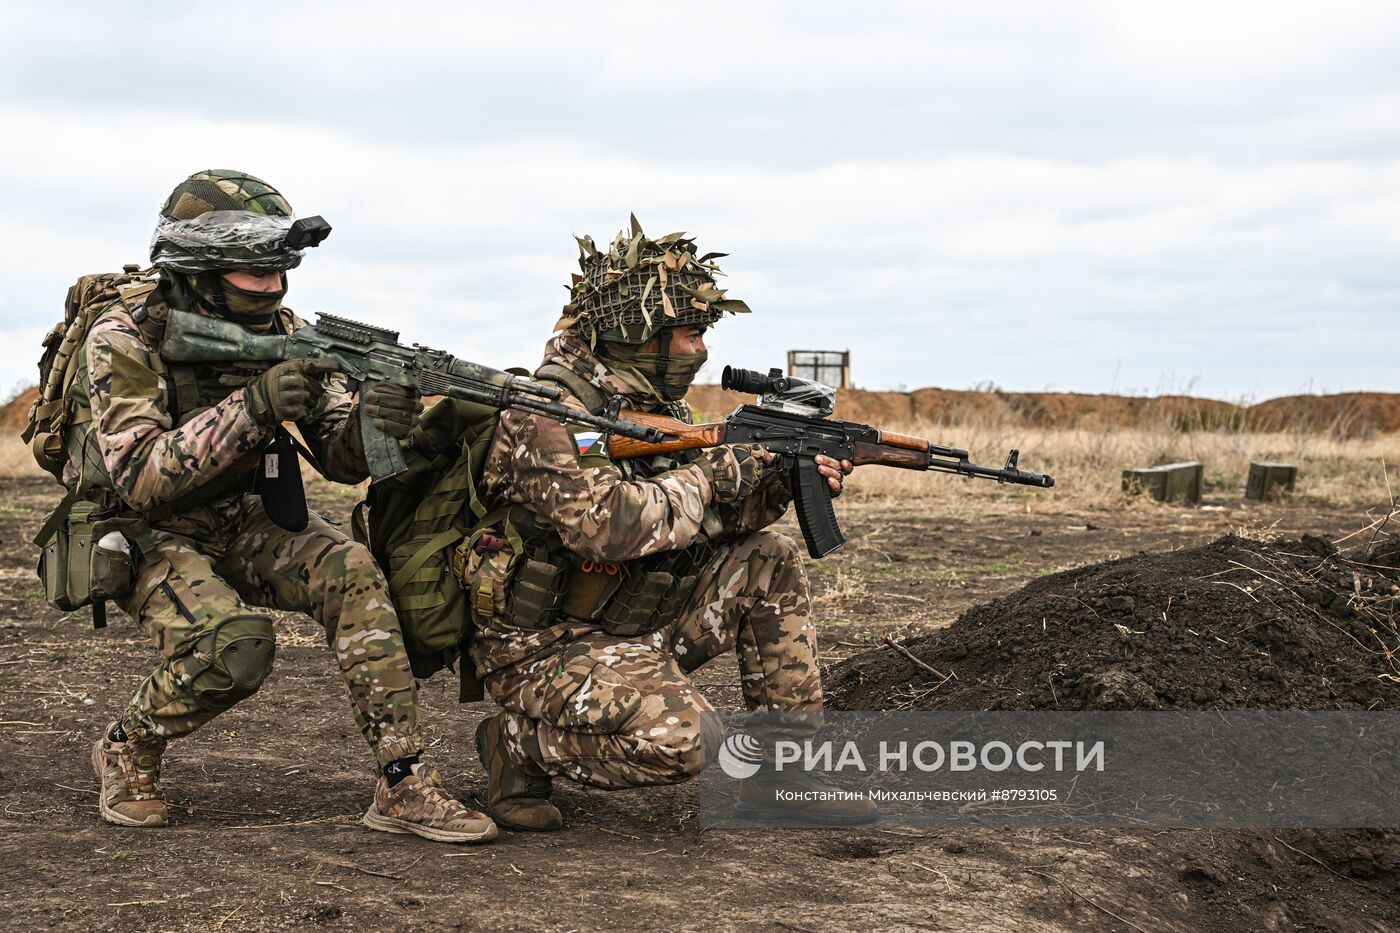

{"left": 161, "top": 308, "right": 662, "bottom": 482}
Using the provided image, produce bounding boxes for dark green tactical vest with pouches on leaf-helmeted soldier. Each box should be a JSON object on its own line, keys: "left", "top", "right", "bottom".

{"left": 490, "top": 364, "right": 720, "bottom": 637}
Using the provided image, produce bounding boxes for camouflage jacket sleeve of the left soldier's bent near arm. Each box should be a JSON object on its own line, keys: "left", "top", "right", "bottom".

{"left": 85, "top": 310, "right": 272, "bottom": 510}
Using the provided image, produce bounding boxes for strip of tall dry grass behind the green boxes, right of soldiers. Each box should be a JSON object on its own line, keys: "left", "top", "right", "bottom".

{"left": 850, "top": 423, "right": 1400, "bottom": 507}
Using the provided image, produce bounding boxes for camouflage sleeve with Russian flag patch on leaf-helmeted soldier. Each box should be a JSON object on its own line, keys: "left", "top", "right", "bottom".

{"left": 486, "top": 410, "right": 713, "bottom": 562}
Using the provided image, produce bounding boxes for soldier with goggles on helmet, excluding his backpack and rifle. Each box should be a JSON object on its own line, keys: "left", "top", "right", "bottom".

{"left": 81, "top": 171, "right": 496, "bottom": 842}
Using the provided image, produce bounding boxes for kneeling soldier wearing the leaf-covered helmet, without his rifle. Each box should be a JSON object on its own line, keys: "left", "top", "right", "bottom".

{"left": 458, "top": 219, "right": 874, "bottom": 831}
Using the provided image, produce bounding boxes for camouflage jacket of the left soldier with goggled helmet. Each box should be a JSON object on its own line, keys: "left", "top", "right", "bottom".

{"left": 85, "top": 280, "right": 368, "bottom": 530}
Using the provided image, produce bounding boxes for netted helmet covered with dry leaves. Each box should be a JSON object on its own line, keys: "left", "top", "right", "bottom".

{"left": 556, "top": 214, "right": 749, "bottom": 346}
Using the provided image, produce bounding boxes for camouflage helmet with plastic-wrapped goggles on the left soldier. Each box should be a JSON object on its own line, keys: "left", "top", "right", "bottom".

{"left": 151, "top": 168, "right": 312, "bottom": 273}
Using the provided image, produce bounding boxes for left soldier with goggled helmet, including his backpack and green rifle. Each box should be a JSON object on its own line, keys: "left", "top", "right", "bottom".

{"left": 25, "top": 171, "right": 648, "bottom": 842}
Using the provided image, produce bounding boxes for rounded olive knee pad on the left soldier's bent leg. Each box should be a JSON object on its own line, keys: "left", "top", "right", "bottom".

{"left": 185, "top": 612, "right": 277, "bottom": 710}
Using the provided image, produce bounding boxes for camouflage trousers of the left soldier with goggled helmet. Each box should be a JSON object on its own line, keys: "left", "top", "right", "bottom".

{"left": 122, "top": 496, "right": 423, "bottom": 765}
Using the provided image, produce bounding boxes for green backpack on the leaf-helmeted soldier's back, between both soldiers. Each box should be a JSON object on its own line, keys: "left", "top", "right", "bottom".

{"left": 354, "top": 383, "right": 525, "bottom": 702}
